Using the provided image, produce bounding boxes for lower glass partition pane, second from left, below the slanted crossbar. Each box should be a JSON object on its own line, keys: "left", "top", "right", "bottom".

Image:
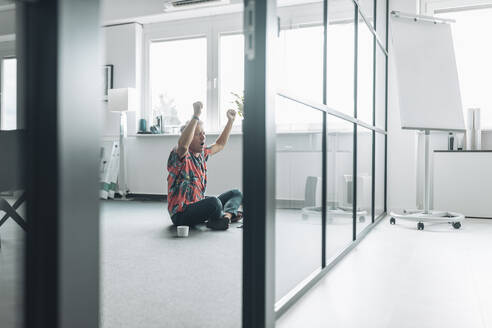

{"left": 326, "top": 115, "right": 354, "bottom": 263}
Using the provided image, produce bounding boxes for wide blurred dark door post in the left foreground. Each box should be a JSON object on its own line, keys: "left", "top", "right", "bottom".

{"left": 16, "top": 0, "right": 102, "bottom": 328}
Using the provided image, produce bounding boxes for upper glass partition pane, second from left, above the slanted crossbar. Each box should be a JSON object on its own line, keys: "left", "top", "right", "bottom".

{"left": 326, "top": 0, "right": 355, "bottom": 116}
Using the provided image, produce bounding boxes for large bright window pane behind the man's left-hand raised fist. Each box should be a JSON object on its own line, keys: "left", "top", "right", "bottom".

{"left": 149, "top": 38, "right": 207, "bottom": 132}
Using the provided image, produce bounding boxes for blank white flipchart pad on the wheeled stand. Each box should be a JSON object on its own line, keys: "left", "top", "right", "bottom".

{"left": 391, "top": 17, "right": 465, "bottom": 130}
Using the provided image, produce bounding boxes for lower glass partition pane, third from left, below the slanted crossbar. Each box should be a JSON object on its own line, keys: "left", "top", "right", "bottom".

{"left": 356, "top": 126, "right": 372, "bottom": 234}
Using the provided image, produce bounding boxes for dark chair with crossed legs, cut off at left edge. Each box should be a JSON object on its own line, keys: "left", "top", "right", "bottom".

{"left": 0, "top": 130, "right": 27, "bottom": 248}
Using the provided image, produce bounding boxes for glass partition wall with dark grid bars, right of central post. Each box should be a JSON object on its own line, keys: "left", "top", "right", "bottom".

{"left": 275, "top": 0, "right": 388, "bottom": 318}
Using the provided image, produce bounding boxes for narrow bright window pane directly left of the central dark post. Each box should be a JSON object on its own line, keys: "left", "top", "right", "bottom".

{"left": 219, "top": 34, "right": 244, "bottom": 126}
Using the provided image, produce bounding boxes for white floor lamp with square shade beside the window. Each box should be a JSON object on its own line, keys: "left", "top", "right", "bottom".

{"left": 108, "top": 88, "right": 137, "bottom": 198}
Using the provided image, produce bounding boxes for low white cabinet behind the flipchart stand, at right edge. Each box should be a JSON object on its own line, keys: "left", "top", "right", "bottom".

{"left": 434, "top": 150, "right": 492, "bottom": 218}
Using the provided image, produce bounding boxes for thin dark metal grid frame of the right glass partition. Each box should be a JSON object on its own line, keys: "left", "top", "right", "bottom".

{"left": 275, "top": 0, "right": 389, "bottom": 319}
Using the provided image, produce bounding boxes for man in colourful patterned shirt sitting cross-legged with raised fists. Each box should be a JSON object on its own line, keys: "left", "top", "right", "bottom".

{"left": 167, "top": 102, "right": 243, "bottom": 230}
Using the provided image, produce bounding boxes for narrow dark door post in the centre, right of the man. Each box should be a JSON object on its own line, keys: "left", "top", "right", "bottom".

{"left": 242, "top": 0, "right": 277, "bottom": 328}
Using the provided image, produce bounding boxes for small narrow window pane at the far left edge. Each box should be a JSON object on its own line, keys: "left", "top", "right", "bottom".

{"left": 0, "top": 58, "right": 17, "bottom": 130}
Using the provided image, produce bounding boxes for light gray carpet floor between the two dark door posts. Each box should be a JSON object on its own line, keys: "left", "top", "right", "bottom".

{"left": 101, "top": 202, "right": 242, "bottom": 328}
